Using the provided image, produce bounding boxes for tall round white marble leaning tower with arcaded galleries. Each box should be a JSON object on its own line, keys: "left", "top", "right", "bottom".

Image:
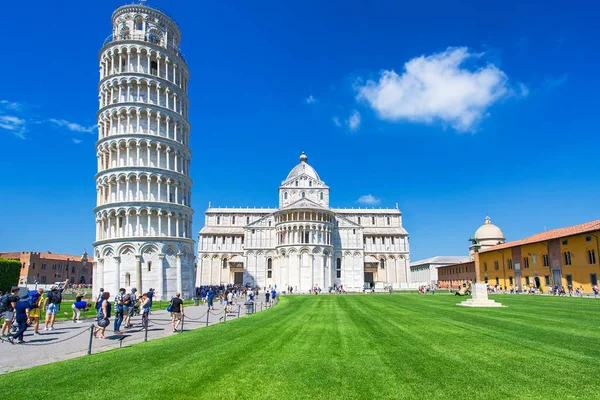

{"left": 94, "top": 4, "right": 195, "bottom": 299}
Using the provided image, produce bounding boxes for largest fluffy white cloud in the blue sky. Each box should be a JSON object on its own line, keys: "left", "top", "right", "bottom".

{"left": 357, "top": 47, "right": 510, "bottom": 132}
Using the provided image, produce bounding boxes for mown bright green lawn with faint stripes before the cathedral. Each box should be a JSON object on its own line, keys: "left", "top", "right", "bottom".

{"left": 0, "top": 294, "right": 600, "bottom": 399}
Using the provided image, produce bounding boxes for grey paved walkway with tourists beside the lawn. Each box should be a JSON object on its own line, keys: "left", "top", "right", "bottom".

{"left": 0, "top": 300, "right": 274, "bottom": 374}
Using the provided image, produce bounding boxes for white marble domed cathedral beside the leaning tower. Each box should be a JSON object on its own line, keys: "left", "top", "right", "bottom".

{"left": 196, "top": 153, "right": 410, "bottom": 292}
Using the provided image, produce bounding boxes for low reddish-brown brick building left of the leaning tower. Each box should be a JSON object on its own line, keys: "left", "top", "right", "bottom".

{"left": 0, "top": 251, "right": 93, "bottom": 285}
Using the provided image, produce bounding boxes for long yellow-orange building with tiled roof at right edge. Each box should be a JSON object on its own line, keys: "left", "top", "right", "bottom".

{"left": 475, "top": 220, "right": 600, "bottom": 292}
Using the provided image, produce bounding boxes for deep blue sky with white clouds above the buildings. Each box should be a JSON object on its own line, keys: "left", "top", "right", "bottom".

{"left": 0, "top": 0, "right": 600, "bottom": 260}
